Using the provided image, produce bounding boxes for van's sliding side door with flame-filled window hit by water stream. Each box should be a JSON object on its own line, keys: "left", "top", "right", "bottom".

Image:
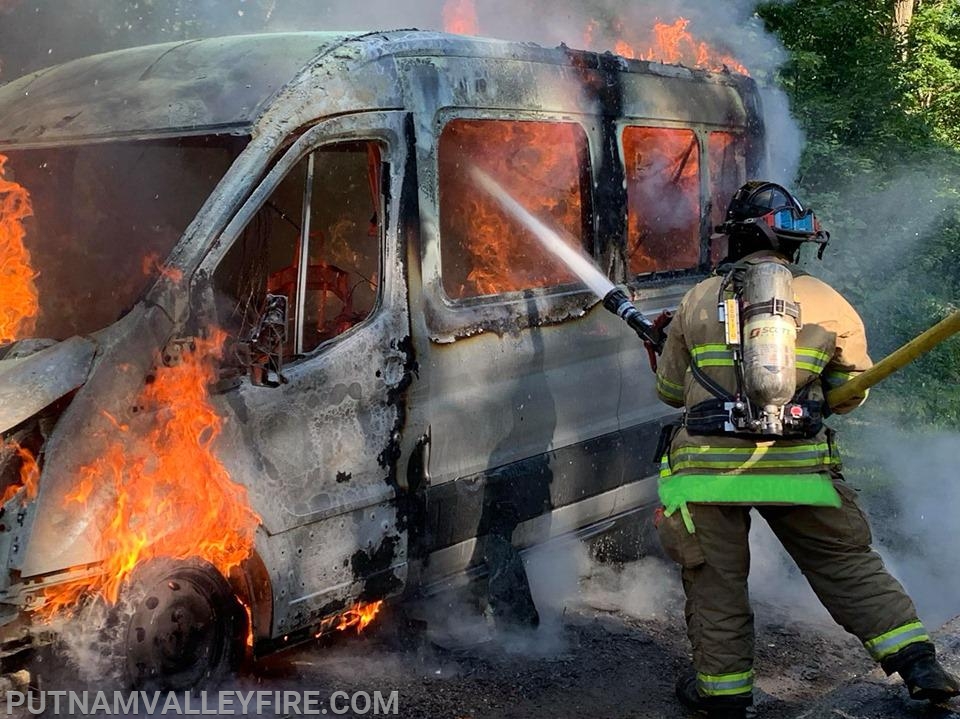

{"left": 410, "top": 110, "right": 622, "bottom": 580}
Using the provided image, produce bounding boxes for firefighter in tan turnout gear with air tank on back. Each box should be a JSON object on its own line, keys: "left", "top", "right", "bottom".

{"left": 657, "top": 181, "right": 960, "bottom": 718}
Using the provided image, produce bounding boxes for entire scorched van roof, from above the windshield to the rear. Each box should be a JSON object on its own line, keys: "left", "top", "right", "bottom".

{"left": 0, "top": 30, "right": 752, "bottom": 149}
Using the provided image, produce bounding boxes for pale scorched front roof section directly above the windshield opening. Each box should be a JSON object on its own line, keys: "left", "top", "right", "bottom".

{"left": 0, "top": 33, "right": 349, "bottom": 145}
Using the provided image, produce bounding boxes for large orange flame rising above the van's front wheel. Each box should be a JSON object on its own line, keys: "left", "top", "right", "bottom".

{"left": 40, "top": 330, "right": 260, "bottom": 617}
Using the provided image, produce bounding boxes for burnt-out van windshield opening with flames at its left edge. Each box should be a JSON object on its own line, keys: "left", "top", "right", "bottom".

{"left": 0, "top": 136, "right": 247, "bottom": 345}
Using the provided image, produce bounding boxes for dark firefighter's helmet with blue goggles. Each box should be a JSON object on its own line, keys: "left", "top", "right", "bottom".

{"left": 718, "top": 180, "right": 830, "bottom": 257}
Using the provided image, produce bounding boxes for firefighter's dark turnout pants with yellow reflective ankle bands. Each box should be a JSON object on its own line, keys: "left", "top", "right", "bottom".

{"left": 658, "top": 474, "right": 929, "bottom": 696}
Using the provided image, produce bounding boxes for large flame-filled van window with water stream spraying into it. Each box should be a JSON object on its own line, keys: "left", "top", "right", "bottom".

{"left": 438, "top": 119, "right": 594, "bottom": 300}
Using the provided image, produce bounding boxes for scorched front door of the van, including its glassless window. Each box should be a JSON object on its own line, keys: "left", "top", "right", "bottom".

{"left": 200, "top": 112, "right": 413, "bottom": 636}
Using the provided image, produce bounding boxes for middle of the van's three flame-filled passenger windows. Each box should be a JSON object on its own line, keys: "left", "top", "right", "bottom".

{"left": 623, "top": 126, "right": 700, "bottom": 276}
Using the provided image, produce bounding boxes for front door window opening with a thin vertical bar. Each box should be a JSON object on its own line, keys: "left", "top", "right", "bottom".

{"left": 214, "top": 142, "right": 382, "bottom": 357}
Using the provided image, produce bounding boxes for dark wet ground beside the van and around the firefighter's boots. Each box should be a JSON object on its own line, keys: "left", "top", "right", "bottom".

{"left": 234, "top": 548, "right": 960, "bottom": 719}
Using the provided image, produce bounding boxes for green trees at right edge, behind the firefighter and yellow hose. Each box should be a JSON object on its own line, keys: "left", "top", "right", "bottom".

{"left": 758, "top": 0, "right": 960, "bottom": 427}
